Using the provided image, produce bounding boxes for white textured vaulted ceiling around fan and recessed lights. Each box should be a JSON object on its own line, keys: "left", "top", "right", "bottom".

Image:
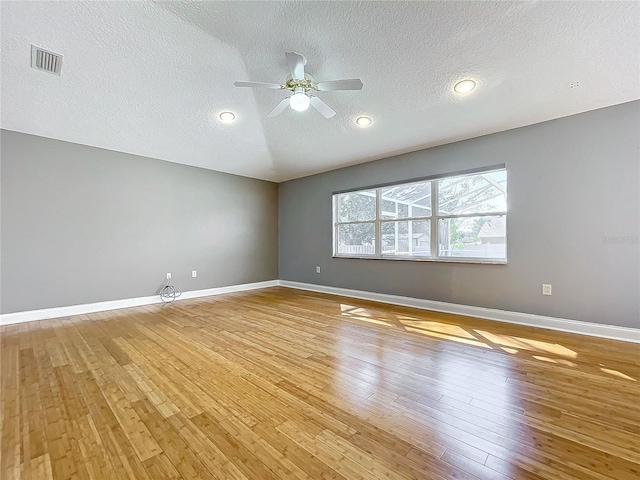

{"left": 0, "top": 1, "right": 640, "bottom": 181}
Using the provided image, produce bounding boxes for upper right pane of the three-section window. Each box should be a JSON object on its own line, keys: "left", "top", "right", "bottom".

{"left": 438, "top": 170, "right": 507, "bottom": 215}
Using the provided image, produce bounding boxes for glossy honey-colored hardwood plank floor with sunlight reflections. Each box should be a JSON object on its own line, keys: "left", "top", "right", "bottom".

{"left": 0, "top": 287, "right": 640, "bottom": 480}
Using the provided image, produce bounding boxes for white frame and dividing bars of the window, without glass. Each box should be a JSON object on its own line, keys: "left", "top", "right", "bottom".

{"left": 332, "top": 165, "right": 508, "bottom": 264}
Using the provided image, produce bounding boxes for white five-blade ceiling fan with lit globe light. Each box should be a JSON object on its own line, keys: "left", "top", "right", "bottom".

{"left": 234, "top": 52, "right": 362, "bottom": 118}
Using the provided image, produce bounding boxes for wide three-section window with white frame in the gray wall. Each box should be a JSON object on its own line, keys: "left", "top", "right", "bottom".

{"left": 333, "top": 166, "right": 507, "bottom": 263}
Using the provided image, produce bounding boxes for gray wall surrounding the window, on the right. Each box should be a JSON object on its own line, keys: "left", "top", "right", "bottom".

{"left": 279, "top": 101, "right": 640, "bottom": 327}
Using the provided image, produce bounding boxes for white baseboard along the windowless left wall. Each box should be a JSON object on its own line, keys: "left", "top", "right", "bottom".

{"left": 0, "top": 280, "right": 279, "bottom": 325}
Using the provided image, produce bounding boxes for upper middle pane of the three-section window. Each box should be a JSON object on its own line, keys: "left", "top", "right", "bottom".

{"left": 382, "top": 182, "right": 431, "bottom": 219}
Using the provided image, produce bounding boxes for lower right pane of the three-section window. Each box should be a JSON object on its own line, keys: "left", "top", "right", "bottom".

{"left": 438, "top": 216, "right": 507, "bottom": 259}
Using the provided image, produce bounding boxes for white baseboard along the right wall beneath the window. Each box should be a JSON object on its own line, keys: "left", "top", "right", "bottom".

{"left": 280, "top": 280, "right": 640, "bottom": 343}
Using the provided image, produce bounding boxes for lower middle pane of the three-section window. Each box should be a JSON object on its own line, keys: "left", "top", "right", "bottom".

{"left": 381, "top": 220, "right": 431, "bottom": 257}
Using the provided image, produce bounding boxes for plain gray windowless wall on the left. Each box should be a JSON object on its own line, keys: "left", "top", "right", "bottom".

{"left": 1, "top": 130, "right": 278, "bottom": 313}
